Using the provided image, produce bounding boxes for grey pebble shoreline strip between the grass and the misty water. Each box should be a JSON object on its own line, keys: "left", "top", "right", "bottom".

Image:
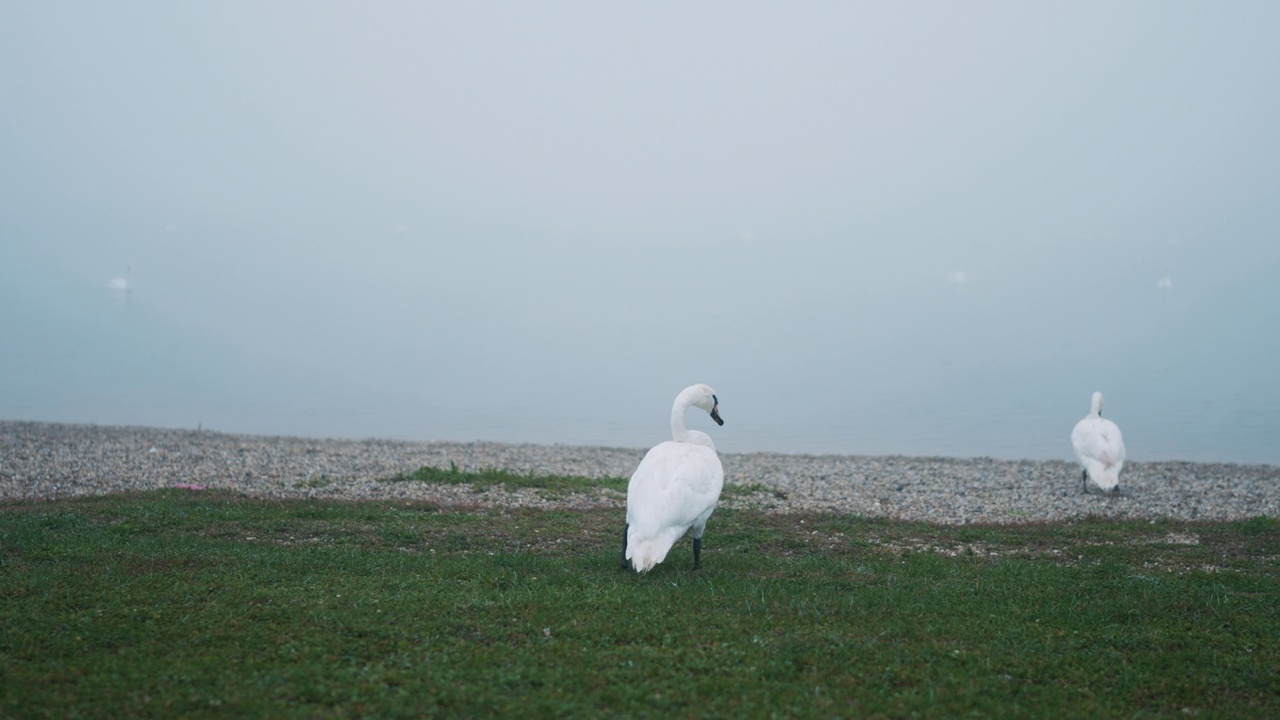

{"left": 0, "top": 420, "right": 1280, "bottom": 524}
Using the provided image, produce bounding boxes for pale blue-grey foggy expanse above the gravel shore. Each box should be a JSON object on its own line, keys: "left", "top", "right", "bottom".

{"left": 0, "top": 1, "right": 1280, "bottom": 462}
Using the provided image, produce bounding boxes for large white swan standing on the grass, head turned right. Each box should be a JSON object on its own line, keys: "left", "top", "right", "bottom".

{"left": 622, "top": 384, "right": 724, "bottom": 573}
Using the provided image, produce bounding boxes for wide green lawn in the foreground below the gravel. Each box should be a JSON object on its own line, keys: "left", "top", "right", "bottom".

{"left": 0, "top": 491, "right": 1280, "bottom": 717}
